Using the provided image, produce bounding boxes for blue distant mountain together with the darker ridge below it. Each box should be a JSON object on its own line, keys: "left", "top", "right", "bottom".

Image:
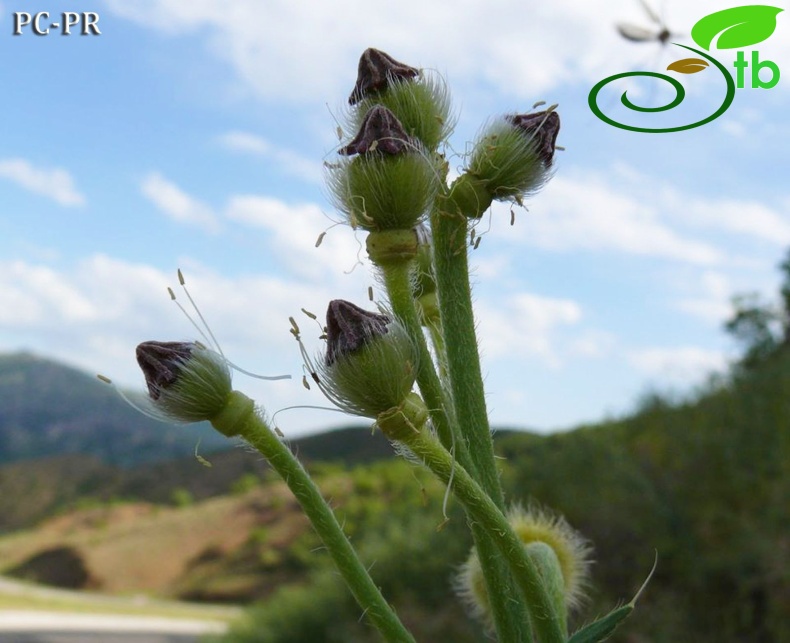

{"left": 0, "top": 353, "right": 393, "bottom": 533}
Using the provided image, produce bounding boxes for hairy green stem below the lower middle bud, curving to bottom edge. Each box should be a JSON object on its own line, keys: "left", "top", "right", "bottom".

{"left": 396, "top": 427, "right": 566, "bottom": 643}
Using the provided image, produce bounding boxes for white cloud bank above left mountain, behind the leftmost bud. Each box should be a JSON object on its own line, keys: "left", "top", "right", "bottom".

{"left": 0, "top": 255, "right": 368, "bottom": 435}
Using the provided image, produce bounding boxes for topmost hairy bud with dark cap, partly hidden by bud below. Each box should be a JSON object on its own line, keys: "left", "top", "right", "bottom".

{"left": 349, "top": 49, "right": 453, "bottom": 150}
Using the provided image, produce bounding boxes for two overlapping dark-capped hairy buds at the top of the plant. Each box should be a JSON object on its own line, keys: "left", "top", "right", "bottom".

{"left": 328, "top": 49, "right": 451, "bottom": 232}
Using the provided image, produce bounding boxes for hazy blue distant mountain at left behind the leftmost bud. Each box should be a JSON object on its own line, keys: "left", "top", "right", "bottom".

{"left": 0, "top": 353, "right": 228, "bottom": 466}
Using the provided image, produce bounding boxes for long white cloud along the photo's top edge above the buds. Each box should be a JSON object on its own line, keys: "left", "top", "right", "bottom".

{"left": 100, "top": 0, "right": 748, "bottom": 102}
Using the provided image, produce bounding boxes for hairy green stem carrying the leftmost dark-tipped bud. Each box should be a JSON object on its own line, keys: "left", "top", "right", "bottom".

{"left": 212, "top": 391, "right": 415, "bottom": 643}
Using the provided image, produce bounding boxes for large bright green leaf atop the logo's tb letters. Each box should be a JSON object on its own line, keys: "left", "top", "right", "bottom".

{"left": 691, "top": 4, "right": 784, "bottom": 51}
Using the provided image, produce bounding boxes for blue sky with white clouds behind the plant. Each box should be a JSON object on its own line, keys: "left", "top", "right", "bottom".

{"left": 0, "top": 0, "right": 790, "bottom": 436}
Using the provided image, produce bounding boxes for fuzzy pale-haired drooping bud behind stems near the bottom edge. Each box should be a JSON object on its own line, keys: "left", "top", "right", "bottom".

{"left": 456, "top": 507, "right": 591, "bottom": 626}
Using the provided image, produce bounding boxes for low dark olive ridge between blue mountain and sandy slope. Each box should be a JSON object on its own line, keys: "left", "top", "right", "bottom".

{"left": 0, "top": 427, "right": 393, "bottom": 534}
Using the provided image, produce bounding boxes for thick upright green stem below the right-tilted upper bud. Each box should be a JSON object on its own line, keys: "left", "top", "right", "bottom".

{"left": 431, "top": 207, "right": 504, "bottom": 509}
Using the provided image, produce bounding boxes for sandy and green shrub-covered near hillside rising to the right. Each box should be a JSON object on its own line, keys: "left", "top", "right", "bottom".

{"left": 0, "top": 350, "right": 790, "bottom": 643}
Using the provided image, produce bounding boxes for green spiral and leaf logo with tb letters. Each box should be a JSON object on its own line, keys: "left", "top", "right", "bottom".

{"left": 587, "top": 5, "right": 783, "bottom": 134}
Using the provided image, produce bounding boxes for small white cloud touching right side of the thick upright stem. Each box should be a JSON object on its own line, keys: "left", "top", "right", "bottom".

{"left": 477, "top": 293, "right": 582, "bottom": 367}
